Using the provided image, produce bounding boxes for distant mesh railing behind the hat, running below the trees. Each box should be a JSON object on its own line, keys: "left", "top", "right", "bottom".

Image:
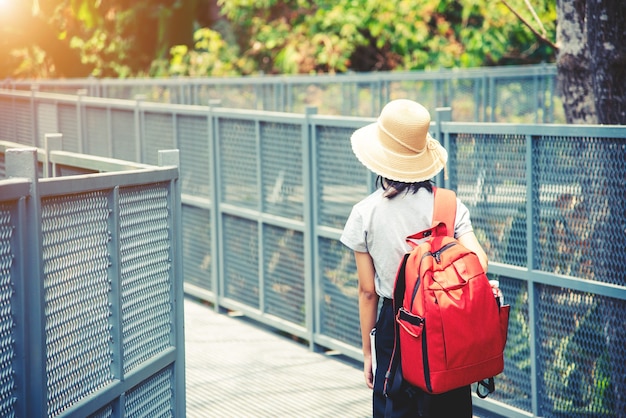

{"left": 5, "top": 64, "right": 565, "bottom": 123}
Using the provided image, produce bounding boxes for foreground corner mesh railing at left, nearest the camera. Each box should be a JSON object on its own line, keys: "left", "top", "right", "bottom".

{"left": 0, "top": 143, "right": 185, "bottom": 417}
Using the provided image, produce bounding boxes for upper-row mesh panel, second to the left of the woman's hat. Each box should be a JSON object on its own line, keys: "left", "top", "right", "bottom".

{"left": 261, "top": 123, "right": 304, "bottom": 220}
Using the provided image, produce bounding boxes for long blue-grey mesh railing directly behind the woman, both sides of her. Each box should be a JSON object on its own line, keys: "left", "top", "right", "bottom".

{"left": 0, "top": 86, "right": 626, "bottom": 416}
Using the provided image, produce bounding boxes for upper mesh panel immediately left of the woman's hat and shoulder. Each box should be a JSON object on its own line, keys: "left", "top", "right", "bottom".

{"left": 316, "top": 126, "right": 370, "bottom": 228}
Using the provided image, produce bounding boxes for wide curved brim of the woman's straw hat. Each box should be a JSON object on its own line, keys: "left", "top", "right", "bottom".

{"left": 350, "top": 122, "right": 448, "bottom": 183}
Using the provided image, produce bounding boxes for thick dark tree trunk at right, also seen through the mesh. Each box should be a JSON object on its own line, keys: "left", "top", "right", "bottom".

{"left": 557, "top": 0, "right": 626, "bottom": 416}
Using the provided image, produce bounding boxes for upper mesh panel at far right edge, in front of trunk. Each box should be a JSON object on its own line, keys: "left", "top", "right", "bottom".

{"left": 533, "top": 137, "right": 626, "bottom": 286}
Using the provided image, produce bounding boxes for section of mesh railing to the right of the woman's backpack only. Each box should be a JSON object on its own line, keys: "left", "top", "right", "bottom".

{"left": 444, "top": 126, "right": 626, "bottom": 417}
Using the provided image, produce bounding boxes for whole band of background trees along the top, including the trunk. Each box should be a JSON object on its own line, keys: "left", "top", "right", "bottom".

{"left": 0, "top": 0, "right": 626, "bottom": 124}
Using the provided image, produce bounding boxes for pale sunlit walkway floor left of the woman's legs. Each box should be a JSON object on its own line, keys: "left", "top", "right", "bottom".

{"left": 185, "top": 299, "right": 371, "bottom": 418}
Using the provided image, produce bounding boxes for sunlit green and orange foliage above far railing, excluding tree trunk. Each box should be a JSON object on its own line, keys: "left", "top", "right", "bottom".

{"left": 0, "top": 0, "right": 556, "bottom": 77}
